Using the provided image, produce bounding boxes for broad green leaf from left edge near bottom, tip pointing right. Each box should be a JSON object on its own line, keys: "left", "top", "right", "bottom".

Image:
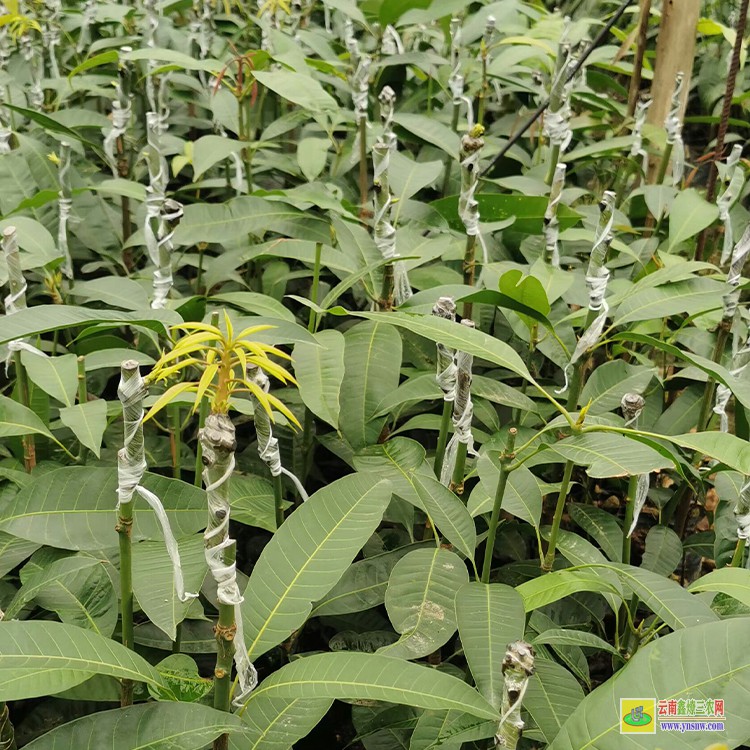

{"left": 0, "top": 620, "right": 162, "bottom": 701}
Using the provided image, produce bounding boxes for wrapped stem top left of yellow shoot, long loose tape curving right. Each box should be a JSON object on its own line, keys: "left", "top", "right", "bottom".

{"left": 117, "top": 360, "right": 198, "bottom": 602}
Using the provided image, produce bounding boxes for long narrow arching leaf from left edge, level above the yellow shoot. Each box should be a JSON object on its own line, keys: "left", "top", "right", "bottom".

{"left": 0, "top": 305, "right": 182, "bottom": 344}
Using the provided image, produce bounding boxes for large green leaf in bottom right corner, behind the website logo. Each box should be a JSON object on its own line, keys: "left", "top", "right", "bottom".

{"left": 549, "top": 617, "right": 750, "bottom": 750}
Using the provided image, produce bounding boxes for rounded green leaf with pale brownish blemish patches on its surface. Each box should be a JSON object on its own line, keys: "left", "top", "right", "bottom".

{"left": 379, "top": 547, "right": 469, "bottom": 659}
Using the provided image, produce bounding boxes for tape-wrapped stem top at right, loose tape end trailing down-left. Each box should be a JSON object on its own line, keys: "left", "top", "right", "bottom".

{"left": 556, "top": 190, "right": 616, "bottom": 395}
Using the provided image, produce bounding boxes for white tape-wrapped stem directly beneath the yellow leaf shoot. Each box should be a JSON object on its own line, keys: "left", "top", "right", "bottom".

{"left": 199, "top": 414, "right": 258, "bottom": 707}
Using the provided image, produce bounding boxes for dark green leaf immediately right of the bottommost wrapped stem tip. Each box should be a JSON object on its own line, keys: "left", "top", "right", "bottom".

{"left": 523, "top": 659, "right": 583, "bottom": 743}
